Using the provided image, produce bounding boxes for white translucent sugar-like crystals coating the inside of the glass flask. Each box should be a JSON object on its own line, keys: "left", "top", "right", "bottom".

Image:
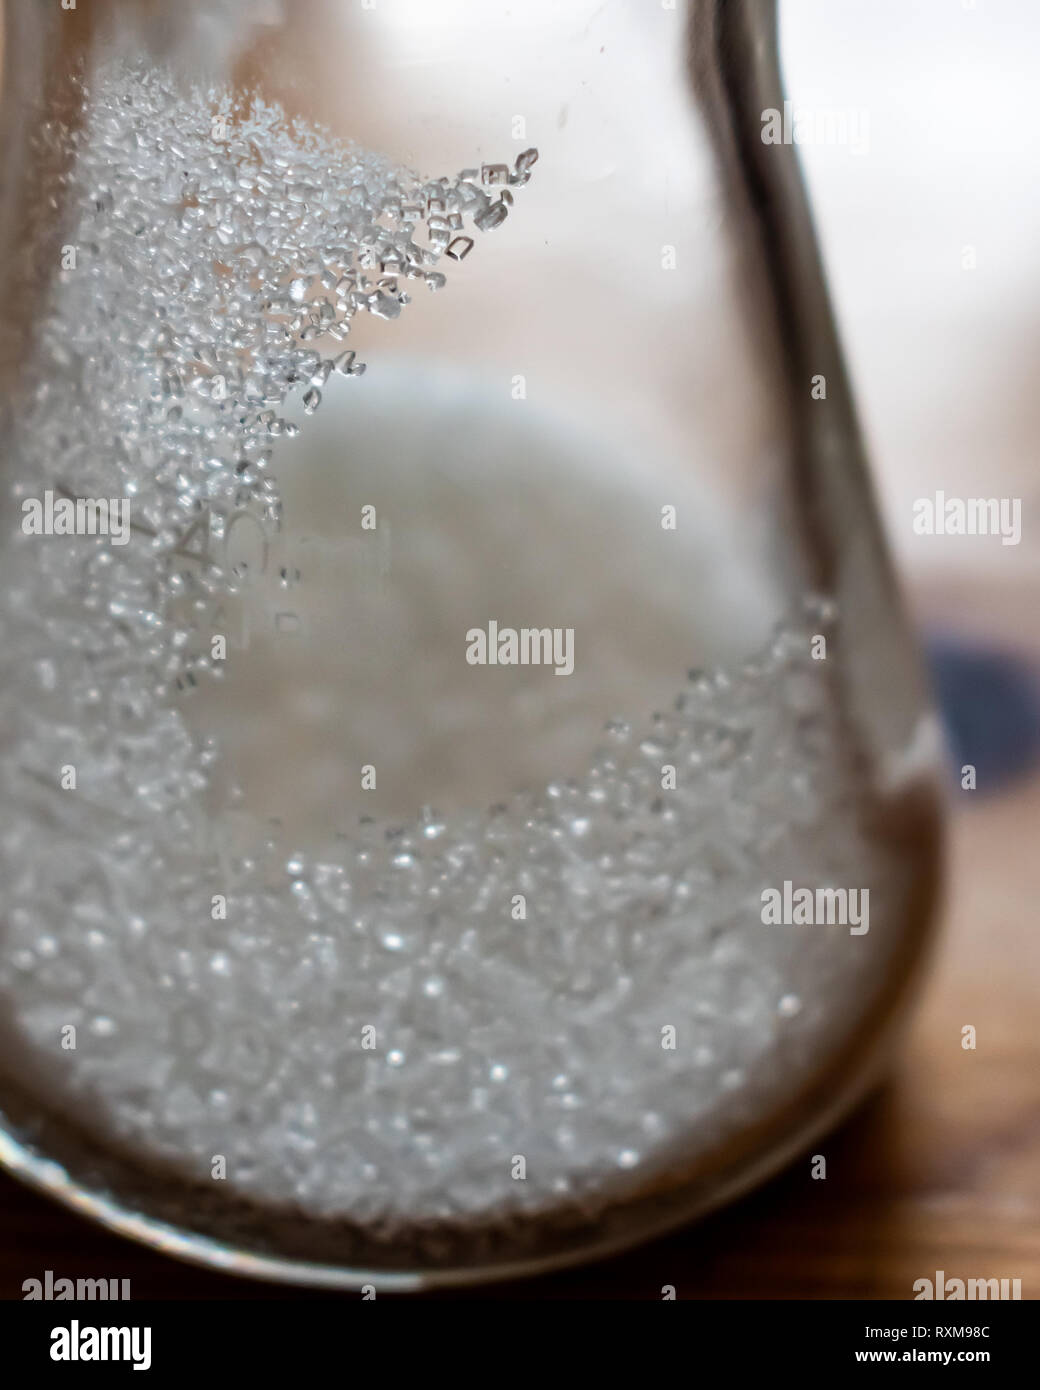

{"left": 0, "top": 56, "right": 904, "bottom": 1240}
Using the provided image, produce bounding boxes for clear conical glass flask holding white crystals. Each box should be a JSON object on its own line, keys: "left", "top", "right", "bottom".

{"left": 0, "top": 0, "right": 939, "bottom": 1289}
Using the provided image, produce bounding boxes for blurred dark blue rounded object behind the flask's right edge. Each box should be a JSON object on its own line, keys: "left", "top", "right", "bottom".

{"left": 925, "top": 632, "right": 1040, "bottom": 792}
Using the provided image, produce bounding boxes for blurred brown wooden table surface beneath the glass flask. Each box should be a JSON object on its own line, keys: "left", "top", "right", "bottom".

{"left": 0, "top": 778, "right": 1040, "bottom": 1300}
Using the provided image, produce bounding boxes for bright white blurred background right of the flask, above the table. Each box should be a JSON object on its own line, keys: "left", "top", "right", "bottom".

{"left": 781, "top": 0, "right": 1040, "bottom": 651}
